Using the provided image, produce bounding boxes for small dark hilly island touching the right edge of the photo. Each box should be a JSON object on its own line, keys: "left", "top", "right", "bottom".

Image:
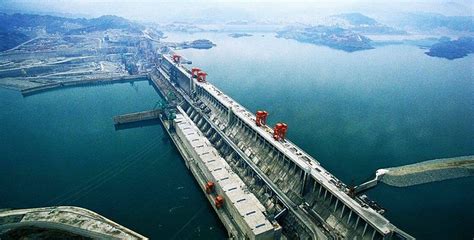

{"left": 426, "top": 37, "right": 474, "bottom": 60}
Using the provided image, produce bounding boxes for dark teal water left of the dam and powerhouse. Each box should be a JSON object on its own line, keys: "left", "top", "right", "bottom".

{"left": 0, "top": 81, "right": 225, "bottom": 239}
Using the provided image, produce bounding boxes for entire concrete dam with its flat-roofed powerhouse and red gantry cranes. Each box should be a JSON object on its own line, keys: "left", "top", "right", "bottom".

{"left": 138, "top": 54, "right": 414, "bottom": 239}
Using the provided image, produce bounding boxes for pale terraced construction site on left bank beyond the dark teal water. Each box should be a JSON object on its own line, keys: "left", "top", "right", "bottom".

{"left": 0, "top": 24, "right": 157, "bottom": 95}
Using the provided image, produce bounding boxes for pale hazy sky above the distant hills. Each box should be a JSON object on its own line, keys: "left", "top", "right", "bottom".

{"left": 0, "top": 0, "right": 473, "bottom": 22}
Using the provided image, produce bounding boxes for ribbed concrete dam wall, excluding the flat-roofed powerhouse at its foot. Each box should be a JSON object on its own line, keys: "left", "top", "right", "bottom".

{"left": 157, "top": 53, "right": 413, "bottom": 239}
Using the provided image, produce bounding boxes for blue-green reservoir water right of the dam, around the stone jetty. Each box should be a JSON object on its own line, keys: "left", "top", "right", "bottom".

{"left": 167, "top": 33, "right": 474, "bottom": 239}
